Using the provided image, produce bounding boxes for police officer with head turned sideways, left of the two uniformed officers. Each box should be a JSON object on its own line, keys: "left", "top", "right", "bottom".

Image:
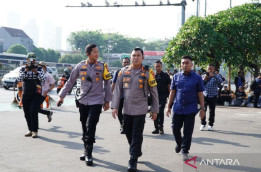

{"left": 57, "top": 44, "right": 112, "bottom": 166}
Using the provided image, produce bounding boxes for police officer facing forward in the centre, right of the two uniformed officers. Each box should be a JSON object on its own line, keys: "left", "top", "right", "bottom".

{"left": 111, "top": 48, "right": 159, "bottom": 171}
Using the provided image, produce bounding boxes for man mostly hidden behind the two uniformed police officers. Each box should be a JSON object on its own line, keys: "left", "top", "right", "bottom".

{"left": 111, "top": 57, "right": 130, "bottom": 134}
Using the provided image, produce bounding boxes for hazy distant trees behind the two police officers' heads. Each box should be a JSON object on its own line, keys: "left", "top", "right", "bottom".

{"left": 67, "top": 30, "right": 168, "bottom": 57}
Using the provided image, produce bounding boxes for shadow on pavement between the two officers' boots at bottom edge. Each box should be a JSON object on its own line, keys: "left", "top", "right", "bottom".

{"left": 93, "top": 157, "right": 127, "bottom": 171}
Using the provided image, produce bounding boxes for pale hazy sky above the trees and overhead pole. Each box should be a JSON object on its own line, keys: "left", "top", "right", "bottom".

{"left": 0, "top": 0, "right": 251, "bottom": 49}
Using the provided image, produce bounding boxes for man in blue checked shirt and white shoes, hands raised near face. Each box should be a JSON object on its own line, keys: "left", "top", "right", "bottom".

{"left": 200, "top": 64, "right": 220, "bottom": 131}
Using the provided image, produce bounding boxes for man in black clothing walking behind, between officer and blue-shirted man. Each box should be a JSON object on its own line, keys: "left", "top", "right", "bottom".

{"left": 152, "top": 60, "right": 171, "bottom": 134}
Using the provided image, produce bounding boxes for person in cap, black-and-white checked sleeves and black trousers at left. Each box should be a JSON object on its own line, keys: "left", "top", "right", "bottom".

{"left": 17, "top": 53, "right": 45, "bottom": 138}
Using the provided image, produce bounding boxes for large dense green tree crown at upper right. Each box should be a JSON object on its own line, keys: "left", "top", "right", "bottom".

{"left": 163, "top": 4, "right": 261, "bottom": 76}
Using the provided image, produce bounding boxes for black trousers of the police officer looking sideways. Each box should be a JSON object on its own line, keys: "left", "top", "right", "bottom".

{"left": 79, "top": 103, "right": 102, "bottom": 145}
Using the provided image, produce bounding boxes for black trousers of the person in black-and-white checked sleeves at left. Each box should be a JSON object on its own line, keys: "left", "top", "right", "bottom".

{"left": 22, "top": 94, "right": 41, "bottom": 132}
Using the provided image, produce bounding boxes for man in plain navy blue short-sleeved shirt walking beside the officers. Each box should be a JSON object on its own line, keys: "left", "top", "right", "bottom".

{"left": 167, "top": 56, "right": 205, "bottom": 161}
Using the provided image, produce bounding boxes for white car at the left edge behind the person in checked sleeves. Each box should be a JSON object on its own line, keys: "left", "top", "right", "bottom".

{"left": 2, "top": 67, "right": 21, "bottom": 90}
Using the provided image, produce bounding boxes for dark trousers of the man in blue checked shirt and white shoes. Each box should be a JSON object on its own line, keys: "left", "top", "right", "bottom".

{"left": 201, "top": 96, "right": 217, "bottom": 126}
